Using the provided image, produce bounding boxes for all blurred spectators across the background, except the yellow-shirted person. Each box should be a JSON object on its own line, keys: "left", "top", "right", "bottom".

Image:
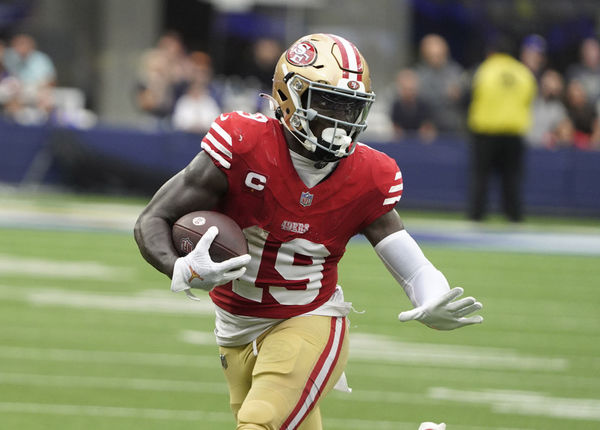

{"left": 0, "top": 32, "right": 600, "bottom": 149}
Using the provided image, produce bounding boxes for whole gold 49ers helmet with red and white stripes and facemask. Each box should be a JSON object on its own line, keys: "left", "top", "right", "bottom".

{"left": 272, "top": 34, "right": 375, "bottom": 161}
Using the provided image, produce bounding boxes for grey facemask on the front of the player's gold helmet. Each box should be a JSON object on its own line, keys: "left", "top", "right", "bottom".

{"left": 287, "top": 74, "right": 375, "bottom": 161}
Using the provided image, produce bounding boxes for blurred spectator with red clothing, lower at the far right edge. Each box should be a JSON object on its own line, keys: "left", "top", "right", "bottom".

{"left": 565, "top": 79, "right": 600, "bottom": 149}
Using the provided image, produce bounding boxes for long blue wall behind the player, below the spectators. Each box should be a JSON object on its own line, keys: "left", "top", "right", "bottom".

{"left": 0, "top": 122, "right": 600, "bottom": 216}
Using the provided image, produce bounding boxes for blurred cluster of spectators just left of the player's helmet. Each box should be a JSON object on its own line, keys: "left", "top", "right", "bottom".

{"left": 135, "top": 32, "right": 282, "bottom": 133}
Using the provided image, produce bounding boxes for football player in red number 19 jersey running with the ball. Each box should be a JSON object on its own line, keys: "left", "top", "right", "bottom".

{"left": 135, "top": 34, "right": 482, "bottom": 430}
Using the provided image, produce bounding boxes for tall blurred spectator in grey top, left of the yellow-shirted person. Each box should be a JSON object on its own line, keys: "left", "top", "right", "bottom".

{"left": 416, "top": 34, "right": 465, "bottom": 132}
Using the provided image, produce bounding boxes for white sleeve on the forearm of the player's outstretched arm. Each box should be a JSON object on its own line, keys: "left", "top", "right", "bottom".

{"left": 375, "top": 230, "right": 450, "bottom": 307}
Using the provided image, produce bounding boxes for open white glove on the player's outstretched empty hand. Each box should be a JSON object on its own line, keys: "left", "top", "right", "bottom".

{"left": 398, "top": 287, "right": 483, "bottom": 330}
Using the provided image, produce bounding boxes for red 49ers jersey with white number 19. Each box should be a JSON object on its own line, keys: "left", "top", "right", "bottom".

{"left": 202, "top": 112, "right": 402, "bottom": 318}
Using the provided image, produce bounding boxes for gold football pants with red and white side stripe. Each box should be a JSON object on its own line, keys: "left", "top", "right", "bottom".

{"left": 219, "top": 315, "right": 348, "bottom": 430}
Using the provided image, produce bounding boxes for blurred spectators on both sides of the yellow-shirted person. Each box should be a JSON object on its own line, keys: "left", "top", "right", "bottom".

{"left": 390, "top": 34, "right": 600, "bottom": 149}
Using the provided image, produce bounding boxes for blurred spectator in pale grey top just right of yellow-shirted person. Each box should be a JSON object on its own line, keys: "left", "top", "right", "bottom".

{"left": 526, "top": 69, "right": 573, "bottom": 148}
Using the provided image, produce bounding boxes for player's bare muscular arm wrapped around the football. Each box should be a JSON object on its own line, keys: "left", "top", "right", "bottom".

{"left": 134, "top": 152, "right": 227, "bottom": 277}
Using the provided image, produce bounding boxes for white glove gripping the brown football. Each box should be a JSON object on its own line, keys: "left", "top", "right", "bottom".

{"left": 171, "top": 226, "right": 250, "bottom": 293}
